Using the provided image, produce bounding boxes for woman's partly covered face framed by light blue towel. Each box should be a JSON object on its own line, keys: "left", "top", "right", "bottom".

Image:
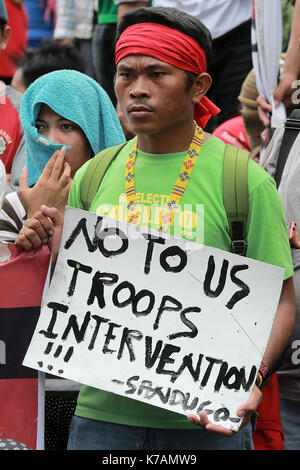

{"left": 35, "top": 104, "right": 91, "bottom": 178}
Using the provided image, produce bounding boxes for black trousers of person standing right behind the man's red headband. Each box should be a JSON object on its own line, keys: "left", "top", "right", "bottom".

{"left": 205, "top": 20, "right": 252, "bottom": 132}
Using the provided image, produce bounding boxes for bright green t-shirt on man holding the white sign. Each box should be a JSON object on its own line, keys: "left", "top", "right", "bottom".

{"left": 69, "top": 137, "right": 293, "bottom": 429}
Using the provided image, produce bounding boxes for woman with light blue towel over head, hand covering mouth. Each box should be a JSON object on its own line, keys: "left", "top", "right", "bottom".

{"left": 0, "top": 70, "right": 125, "bottom": 242}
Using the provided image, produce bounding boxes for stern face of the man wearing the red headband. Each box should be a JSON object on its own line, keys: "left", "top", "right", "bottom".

{"left": 115, "top": 55, "right": 195, "bottom": 135}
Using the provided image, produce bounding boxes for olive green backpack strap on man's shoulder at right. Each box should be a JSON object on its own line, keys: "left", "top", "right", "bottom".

{"left": 223, "top": 144, "right": 249, "bottom": 256}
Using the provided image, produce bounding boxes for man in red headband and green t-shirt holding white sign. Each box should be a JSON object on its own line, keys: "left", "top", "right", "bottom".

{"left": 15, "top": 4, "right": 295, "bottom": 450}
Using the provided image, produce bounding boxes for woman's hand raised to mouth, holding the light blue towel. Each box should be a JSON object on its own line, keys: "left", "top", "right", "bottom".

{"left": 18, "top": 147, "right": 72, "bottom": 218}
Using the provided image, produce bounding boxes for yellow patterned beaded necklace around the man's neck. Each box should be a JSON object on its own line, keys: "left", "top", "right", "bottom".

{"left": 125, "top": 122, "right": 204, "bottom": 233}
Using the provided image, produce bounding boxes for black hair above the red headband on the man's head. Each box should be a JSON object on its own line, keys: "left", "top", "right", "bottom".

{"left": 115, "top": 7, "right": 212, "bottom": 63}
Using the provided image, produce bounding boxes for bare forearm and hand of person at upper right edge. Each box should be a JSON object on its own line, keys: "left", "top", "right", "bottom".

{"left": 257, "top": 0, "right": 300, "bottom": 127}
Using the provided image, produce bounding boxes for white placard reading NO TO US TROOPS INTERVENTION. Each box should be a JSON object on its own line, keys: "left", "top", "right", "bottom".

{"left": 24, "top": 208, "right": 284, "bottom": 430}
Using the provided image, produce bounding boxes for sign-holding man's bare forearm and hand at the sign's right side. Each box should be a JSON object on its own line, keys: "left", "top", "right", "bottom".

{"left": 187, "top": 278, "right": 296, "bottom": 437}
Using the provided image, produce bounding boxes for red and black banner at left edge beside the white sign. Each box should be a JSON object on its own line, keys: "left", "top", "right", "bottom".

{"left": 0, "top": 243, "right": 50, "bottom": 450}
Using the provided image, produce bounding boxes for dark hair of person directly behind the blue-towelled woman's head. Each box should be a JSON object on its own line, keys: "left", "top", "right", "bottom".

{"left": 16, "top": 42, "right": 85, "bottom": 88}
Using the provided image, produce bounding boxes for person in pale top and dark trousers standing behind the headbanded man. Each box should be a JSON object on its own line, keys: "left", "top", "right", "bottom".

{"left": 113, "top": 0, "right": 252, "bottom": 132}
